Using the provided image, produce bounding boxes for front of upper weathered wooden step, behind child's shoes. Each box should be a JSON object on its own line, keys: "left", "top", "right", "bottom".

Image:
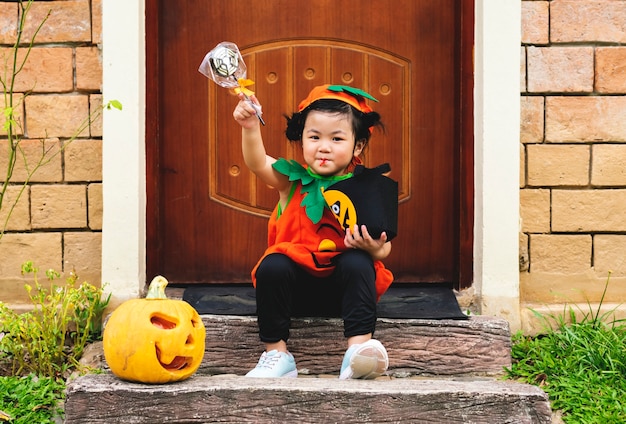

{"left": 198, "top": 315, "right": 511, "bottom": 377}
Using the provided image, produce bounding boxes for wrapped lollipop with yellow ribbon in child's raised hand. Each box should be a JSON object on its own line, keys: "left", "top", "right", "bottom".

{"left": 198, "top": 41, "right": 265, "bottom": 125}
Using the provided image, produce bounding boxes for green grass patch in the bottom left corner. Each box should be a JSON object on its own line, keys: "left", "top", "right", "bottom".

{"left": 0, "top": 374, "right": 65, "bottom": 424}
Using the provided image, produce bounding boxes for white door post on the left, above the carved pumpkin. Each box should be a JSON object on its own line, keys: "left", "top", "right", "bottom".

{"left": 102, "top": 0, "right": 146, "bottom": 301}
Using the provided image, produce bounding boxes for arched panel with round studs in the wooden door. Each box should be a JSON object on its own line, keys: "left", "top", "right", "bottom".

{"left": 207, "top": 40, "right": 413, "bottom": 217}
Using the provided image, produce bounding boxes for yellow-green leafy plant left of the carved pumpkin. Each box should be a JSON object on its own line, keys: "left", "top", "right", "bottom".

{"left": 0, "top": 261, "right": 110, "bottom": 378}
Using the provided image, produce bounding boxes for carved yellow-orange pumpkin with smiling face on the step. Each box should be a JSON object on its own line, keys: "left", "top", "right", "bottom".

{"left": 103, "top": 276, "right": 206, "bottom": 383}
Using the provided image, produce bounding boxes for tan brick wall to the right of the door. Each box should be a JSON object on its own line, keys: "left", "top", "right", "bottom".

{"left": 520, "top": 0, "right": 626, "bottom": 303}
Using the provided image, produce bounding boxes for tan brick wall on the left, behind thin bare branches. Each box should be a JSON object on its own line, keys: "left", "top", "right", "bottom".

{"left": 0, "top": 0, "right": 102, "bottom": 303}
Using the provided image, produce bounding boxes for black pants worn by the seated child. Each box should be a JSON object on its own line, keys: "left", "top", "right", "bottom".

{"left": 256, "top": 249, "right": 376, "bottom": 343}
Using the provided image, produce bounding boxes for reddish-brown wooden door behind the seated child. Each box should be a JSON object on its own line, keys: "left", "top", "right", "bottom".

{"left": 146, "top": 0, "right": 473, "bottom": 287}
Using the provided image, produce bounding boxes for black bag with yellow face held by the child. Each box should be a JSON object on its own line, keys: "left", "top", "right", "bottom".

{"left": 324, "top": 163, "right": 398, "bottom": 240}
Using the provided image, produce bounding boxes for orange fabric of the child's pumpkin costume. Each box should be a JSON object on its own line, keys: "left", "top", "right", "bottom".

{"left": 252, "top": 173, "right": 393, "bottom": 300}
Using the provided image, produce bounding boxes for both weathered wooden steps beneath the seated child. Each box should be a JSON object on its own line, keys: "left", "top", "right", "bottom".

{"left": 65, "top": 315, "right": 551, "bottom": 424}
